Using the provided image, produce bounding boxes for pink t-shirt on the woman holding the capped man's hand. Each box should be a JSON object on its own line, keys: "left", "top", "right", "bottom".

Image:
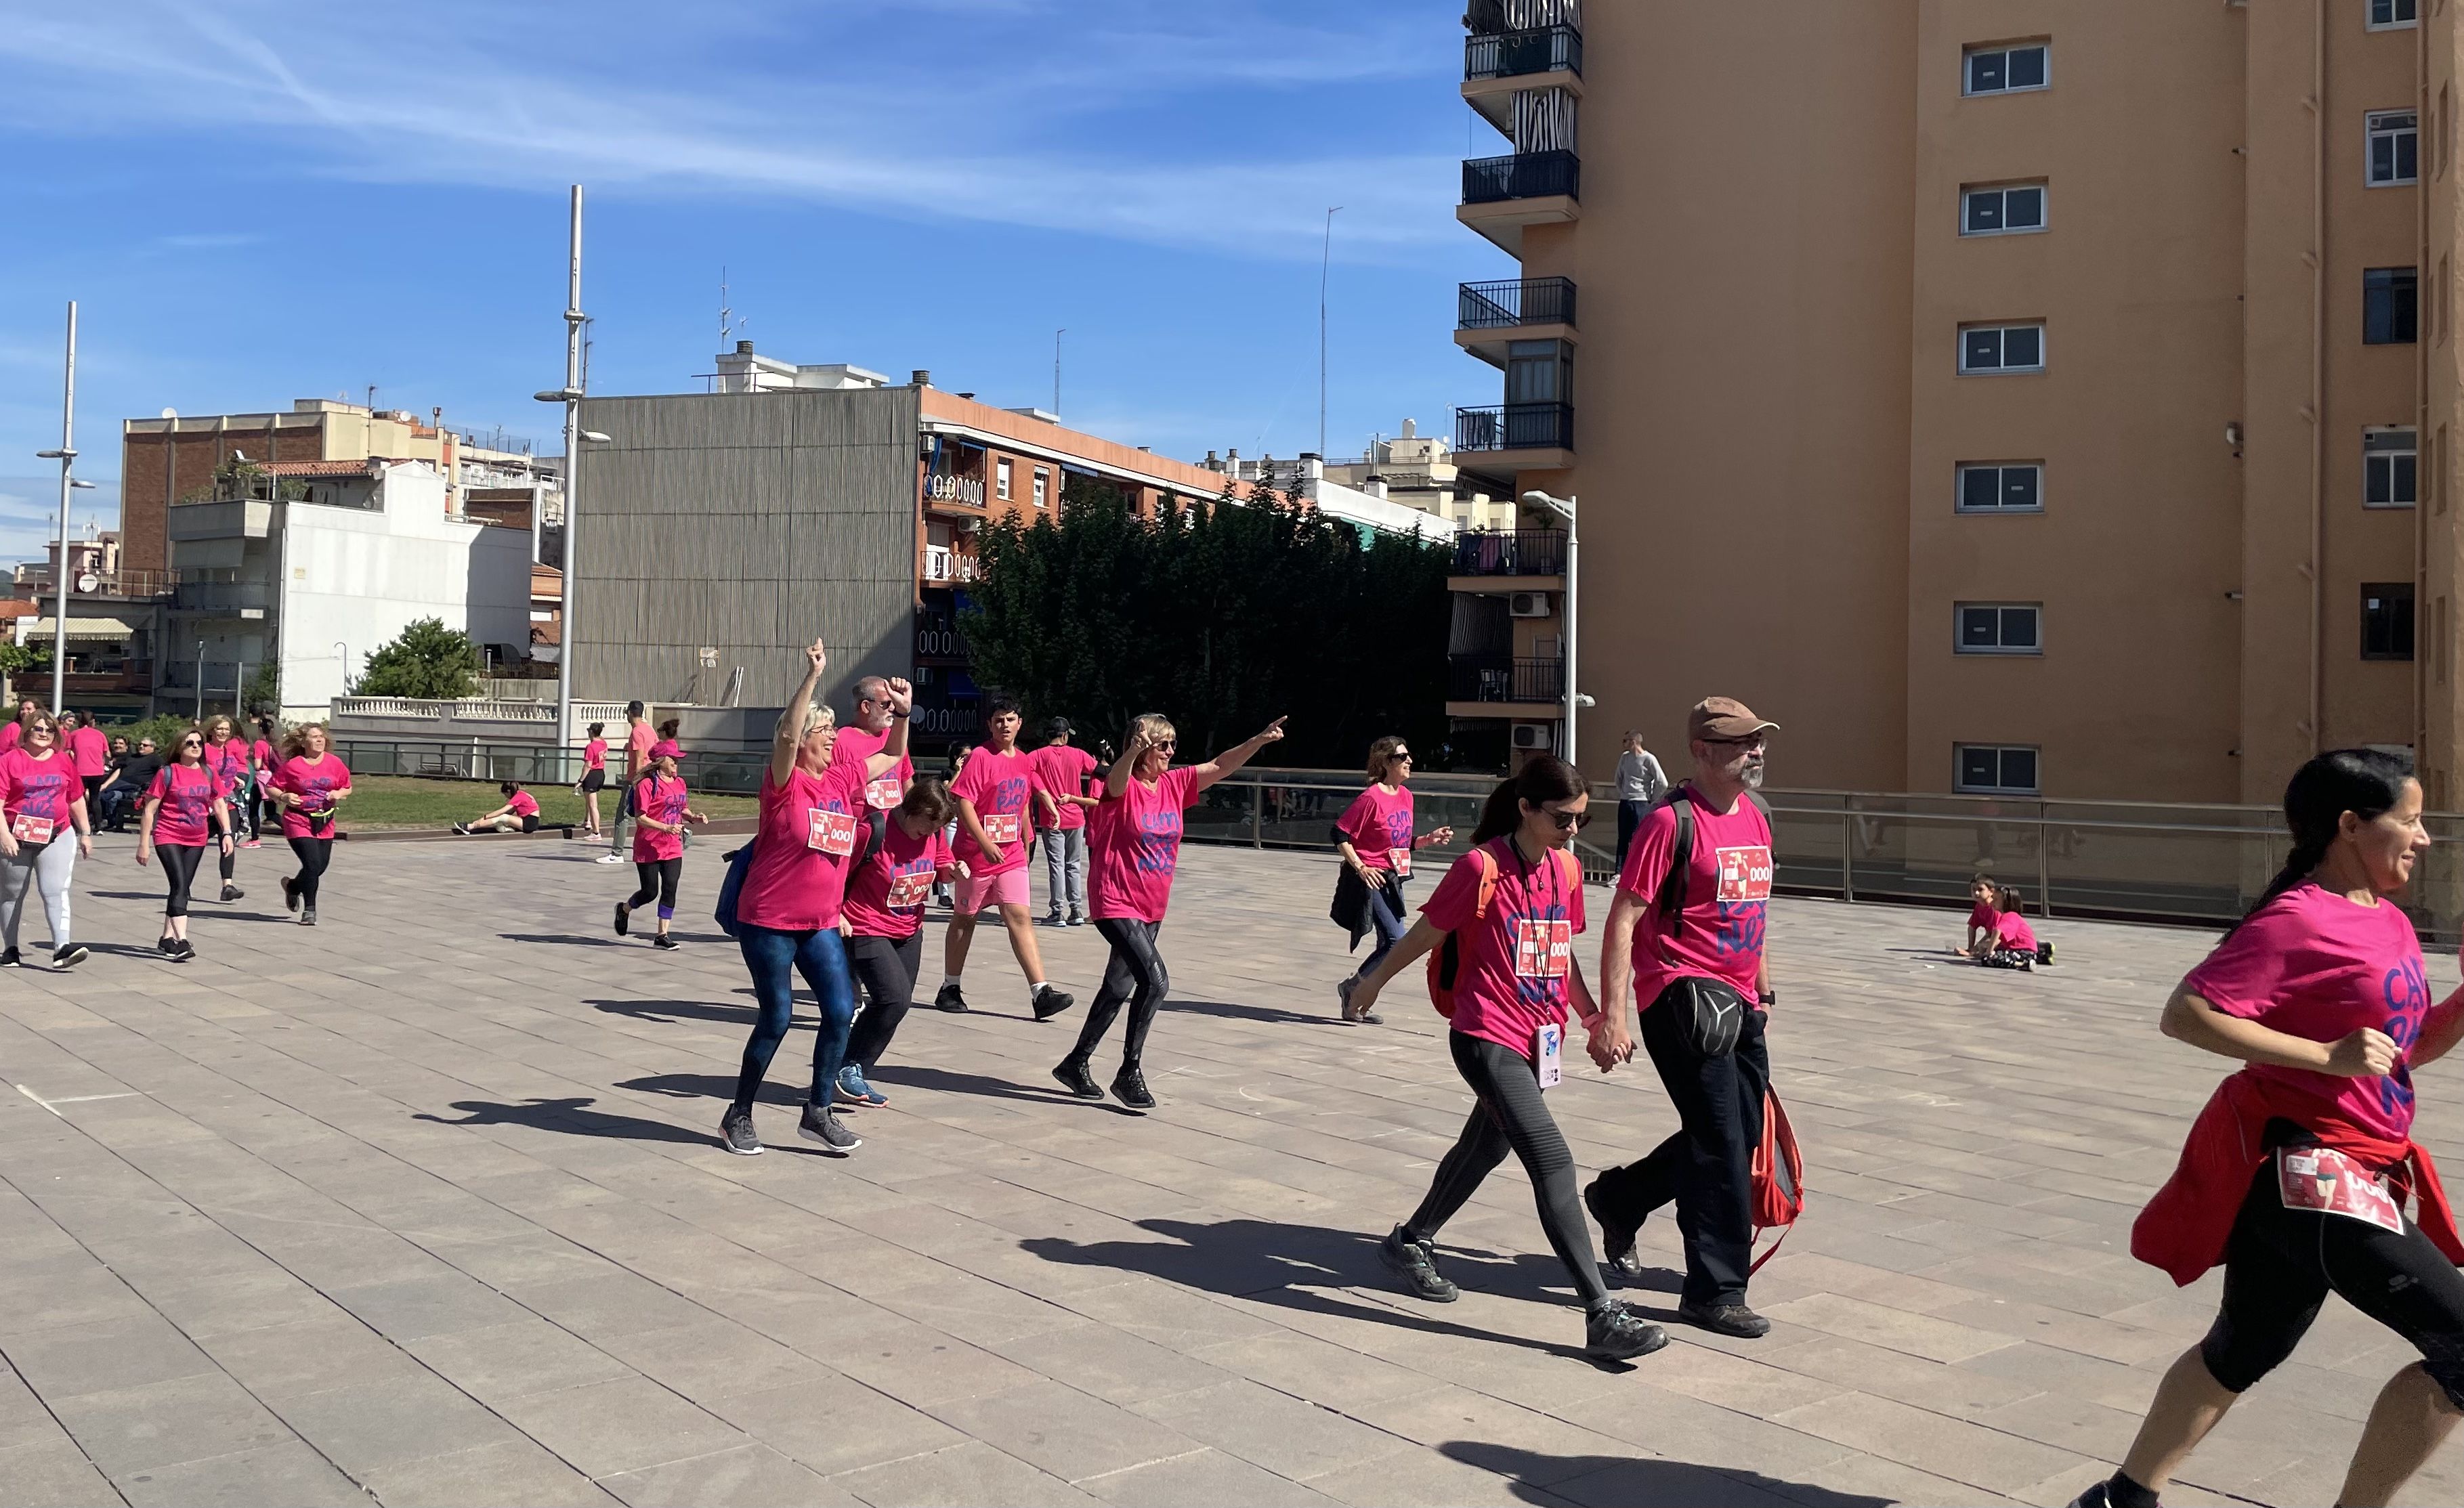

{"left": 1419, "top": 838, "right": 1584, "bottom": 1057}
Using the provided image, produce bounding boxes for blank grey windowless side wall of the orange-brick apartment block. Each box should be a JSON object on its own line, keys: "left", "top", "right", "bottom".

{"left": 572, "top": 387, "right": 916, "bottom": 712}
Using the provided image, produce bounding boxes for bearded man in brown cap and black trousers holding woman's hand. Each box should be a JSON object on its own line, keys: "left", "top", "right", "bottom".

{"left": 1582, "top": 697, "right": 1779, "bottom": 1338}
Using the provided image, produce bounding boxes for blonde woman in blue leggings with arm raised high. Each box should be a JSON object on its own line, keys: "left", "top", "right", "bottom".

{"left": 719, "top": 638, "right": 914, "bottom": 1156}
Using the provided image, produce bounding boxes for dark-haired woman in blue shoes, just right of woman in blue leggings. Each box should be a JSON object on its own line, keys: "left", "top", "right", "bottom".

{"left": 838, "top": 776, "right": 958, "bottom": 1104}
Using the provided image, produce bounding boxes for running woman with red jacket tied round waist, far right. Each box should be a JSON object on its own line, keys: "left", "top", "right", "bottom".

{"left": 2077, "top": 749, "right": 2464, "bottom": 1508}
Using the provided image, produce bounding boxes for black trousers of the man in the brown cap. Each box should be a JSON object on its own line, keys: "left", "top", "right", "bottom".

{"left": 1599, "top": 993, "right": 1772, "bottom": 1304}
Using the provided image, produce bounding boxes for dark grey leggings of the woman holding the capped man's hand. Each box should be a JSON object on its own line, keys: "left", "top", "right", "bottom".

{"left": 1402, "top": 1033, "right": 1609, "bottom": 1306}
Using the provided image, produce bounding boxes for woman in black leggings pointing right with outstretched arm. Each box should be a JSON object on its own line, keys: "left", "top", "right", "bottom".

{"left": 1035, "top": 712, "right": 1283, "bottom": 1111}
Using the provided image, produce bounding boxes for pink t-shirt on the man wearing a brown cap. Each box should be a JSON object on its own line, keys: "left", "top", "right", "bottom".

{"left": 1617, "top": 783, "right": 1772, "bottom": 1010}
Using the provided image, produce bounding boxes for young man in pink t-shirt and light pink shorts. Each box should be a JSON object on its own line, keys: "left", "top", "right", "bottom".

{"left": 934, "top": 697, "right": 1077, "bottom": 1020}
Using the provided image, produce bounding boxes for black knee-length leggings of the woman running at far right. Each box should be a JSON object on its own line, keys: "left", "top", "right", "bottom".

{"left": 2198, "top": 1156, "right": 2464, "bottom": 1409}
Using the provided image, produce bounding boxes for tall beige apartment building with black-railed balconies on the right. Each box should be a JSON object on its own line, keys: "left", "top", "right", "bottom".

{"left": 1449, "top": 0, "right": 2464, "bottom": 809}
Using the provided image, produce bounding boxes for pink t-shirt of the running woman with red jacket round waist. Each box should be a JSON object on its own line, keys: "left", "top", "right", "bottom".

{"left": 2181, "top": 882, "right": 2429, "bottom": 1141}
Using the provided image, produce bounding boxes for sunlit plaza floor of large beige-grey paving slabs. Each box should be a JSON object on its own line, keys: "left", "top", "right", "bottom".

{"left": 0, "top": 838, "right": 2464, "bottom": 1508}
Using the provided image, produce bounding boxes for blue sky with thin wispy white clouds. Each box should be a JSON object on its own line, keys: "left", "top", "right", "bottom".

{"left": 0, "top": 0, "right": 1510, "bottom": 559}
